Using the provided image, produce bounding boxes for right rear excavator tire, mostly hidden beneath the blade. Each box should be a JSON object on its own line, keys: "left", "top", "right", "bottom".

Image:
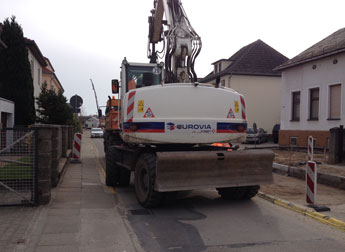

{"left": 217, "top": 185, "right": 260, "bottom": 200}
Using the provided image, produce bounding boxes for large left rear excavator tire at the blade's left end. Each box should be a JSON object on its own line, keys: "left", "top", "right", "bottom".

{"left": 134, "top": 153, "right": 163, "bottom": 208}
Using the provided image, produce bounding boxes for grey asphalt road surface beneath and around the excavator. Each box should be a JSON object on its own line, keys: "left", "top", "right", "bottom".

{"left": 92, "top": 139, "right": 345, "bottom": 252}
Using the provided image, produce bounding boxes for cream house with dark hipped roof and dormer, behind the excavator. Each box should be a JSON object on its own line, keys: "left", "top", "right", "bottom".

{"left": 201, "top": 40, "right": 288, "bottom": 132}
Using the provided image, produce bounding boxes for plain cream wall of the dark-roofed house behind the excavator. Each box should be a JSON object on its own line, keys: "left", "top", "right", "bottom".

{"left": 227, "top": 75, "right": 282, "bottom": 133}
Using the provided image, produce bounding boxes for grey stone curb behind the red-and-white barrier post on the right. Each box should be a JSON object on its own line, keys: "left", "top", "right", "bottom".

{"left": 273, "top": 163, "right": 345, "bottom": 190}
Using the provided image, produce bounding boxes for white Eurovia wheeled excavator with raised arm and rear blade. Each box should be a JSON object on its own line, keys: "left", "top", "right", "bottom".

{"left": 104, "top": 0, "right": 274, "bottom": 208}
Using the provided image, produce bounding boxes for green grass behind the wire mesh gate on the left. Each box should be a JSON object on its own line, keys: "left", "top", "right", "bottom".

{"left": 0, "top": 156, "right": 33, "bottom": 181}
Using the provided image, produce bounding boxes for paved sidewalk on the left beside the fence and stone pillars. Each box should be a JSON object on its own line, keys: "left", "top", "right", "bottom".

{"left": 0, "top": 137, "right": 138, "bottom": 252}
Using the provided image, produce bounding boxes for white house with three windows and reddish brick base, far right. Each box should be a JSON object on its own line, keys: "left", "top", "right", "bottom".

{"left": 276, "top": 28, "right": 345, "bottom": 148}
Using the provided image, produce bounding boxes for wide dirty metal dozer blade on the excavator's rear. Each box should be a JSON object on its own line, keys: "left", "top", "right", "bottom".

{"left": 155, "top": 150, "right": 274, "bottom": 192}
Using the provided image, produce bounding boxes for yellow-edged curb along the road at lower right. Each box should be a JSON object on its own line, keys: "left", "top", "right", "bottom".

{"left": 257, "top": 192, "right": 345, "bottom": 232}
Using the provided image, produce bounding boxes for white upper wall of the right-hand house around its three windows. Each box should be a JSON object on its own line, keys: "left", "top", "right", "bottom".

{"left": 280, "top": 54, "right": 345, "bottom": 130}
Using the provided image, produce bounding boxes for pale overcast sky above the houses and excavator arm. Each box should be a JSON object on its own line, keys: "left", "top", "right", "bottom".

{"left": 0, "top": 0, "right": 345, "bottom": 115}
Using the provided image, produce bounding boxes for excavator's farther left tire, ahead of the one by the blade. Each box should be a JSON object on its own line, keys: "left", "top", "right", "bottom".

{"left": 105, "top": 146, "right": 121, "bottom": 186}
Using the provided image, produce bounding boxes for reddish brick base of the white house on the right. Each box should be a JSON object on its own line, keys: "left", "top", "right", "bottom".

{"left": 279, "top": 130, "right": 329, "bottom": 148}
